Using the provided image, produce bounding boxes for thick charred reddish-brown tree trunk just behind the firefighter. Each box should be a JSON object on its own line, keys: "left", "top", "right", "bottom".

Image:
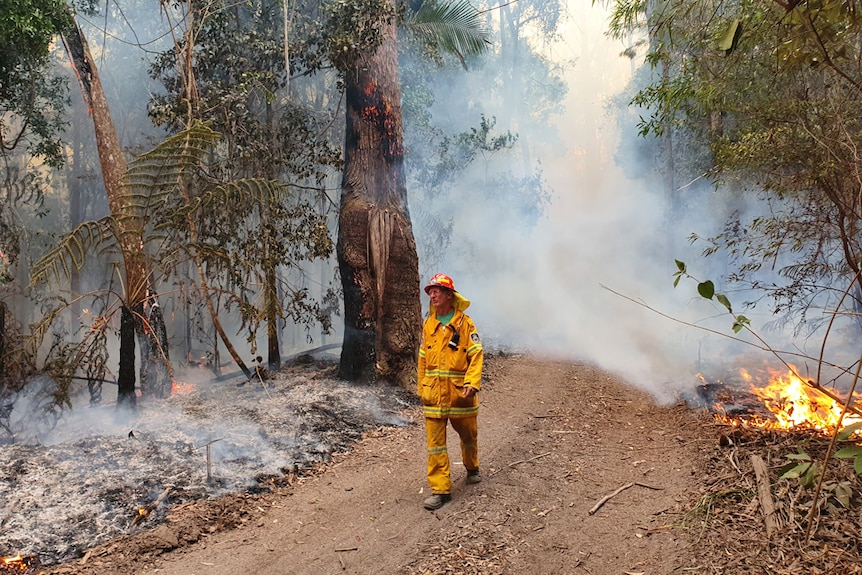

{"left": 337, "top": 5, "right": 422, "bottom": 387}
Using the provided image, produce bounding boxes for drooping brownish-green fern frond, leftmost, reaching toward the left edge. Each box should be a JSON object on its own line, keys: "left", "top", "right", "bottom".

{"left": 30, "top": 216, "right": 117, "bottom": 285}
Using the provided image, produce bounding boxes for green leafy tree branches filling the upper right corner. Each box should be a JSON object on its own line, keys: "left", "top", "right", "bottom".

{"left": 611, "top": 0, "right": 862, "bottom": 330}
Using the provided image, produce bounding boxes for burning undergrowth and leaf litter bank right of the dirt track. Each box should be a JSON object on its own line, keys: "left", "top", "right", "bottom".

{"left": 687, "top": 366, "right": 862, "bottom": 575}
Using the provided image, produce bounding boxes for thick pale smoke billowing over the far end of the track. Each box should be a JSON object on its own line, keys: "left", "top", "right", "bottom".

{"left": 422, "top": 6, "right": 808, "bottom": 401}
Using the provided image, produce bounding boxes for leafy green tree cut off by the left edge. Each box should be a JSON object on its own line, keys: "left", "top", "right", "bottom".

{"left": 0, "top": 0, "right": 67, "bottom": 396}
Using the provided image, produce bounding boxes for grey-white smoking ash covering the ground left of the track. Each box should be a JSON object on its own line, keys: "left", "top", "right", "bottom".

{"left": 0, "top": 361, "right": 416, "bottom": 565}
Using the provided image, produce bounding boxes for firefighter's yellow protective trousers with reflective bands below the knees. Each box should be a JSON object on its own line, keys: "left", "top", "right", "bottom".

{"left": 425, "top": 415, "right": 479, "bottom": 493}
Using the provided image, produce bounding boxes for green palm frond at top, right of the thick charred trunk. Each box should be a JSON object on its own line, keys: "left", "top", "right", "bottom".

{"left": 402, "top": 0, "right": 491, "bottom": 68}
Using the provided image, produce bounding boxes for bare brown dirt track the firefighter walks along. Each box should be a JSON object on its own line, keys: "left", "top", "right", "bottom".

{"left": 38, "top": 357, "right": 714, "bottom": 575}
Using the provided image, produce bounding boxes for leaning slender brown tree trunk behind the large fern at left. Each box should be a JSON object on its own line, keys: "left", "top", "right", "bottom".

{"left": 62, "top": 17, "right": 172, "bottom": 406}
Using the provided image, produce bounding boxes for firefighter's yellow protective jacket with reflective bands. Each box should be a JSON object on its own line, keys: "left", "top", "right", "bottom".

{"left": 417, "top": 292, "right": 484, "bottom": 418}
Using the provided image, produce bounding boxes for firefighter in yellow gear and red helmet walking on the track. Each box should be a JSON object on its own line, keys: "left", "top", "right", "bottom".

{"left": 417, "top": 274, "right": 483, "bottom": 510}
